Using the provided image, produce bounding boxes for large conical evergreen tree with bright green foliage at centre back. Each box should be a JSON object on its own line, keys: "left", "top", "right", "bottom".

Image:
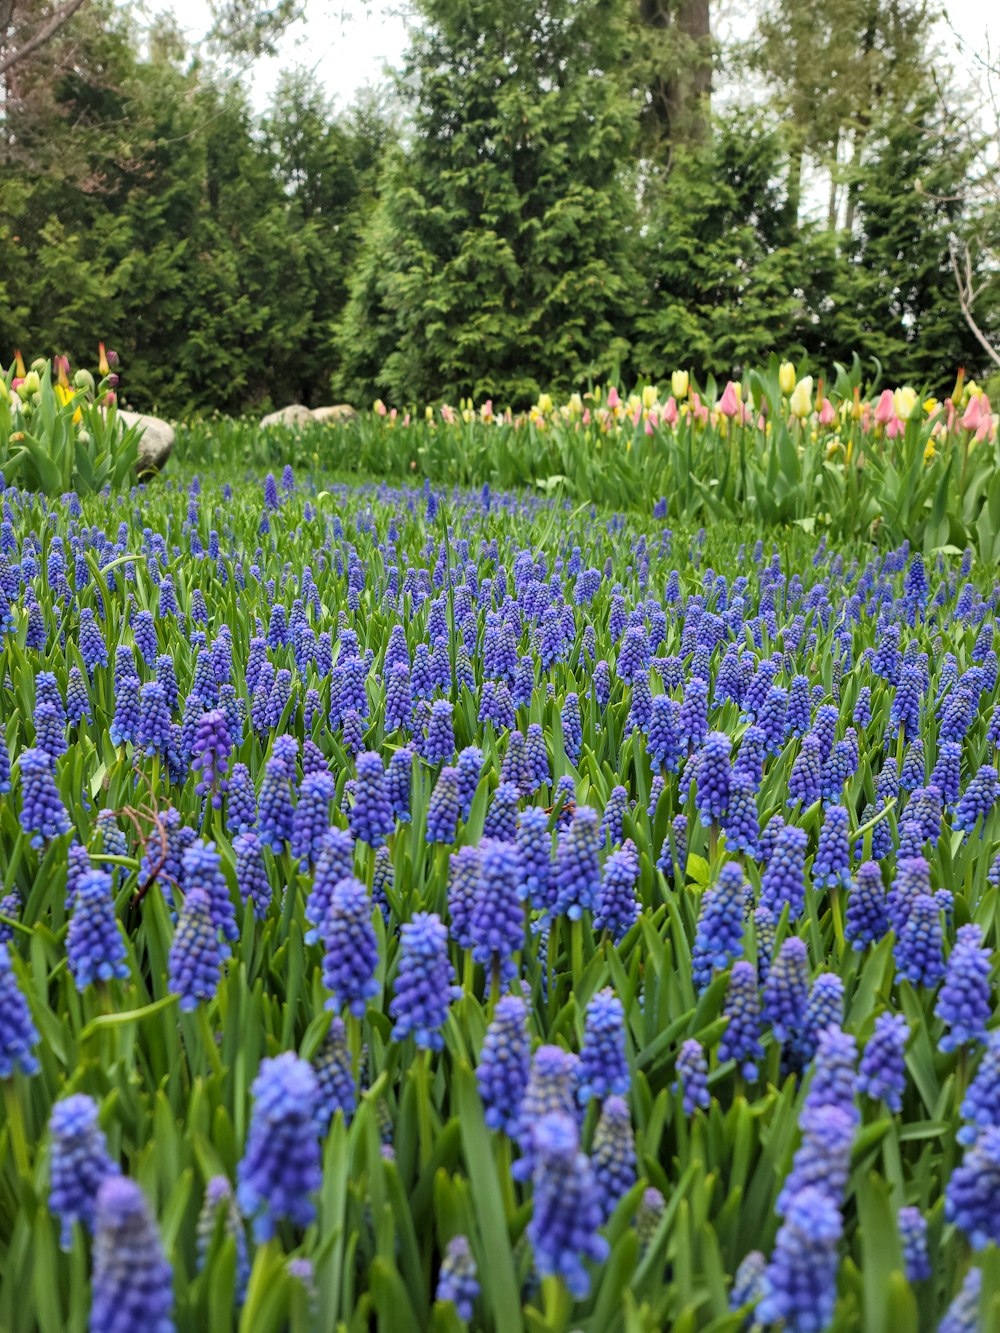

{"left": 337, "top": 0, "right": 636, "bottom": 403}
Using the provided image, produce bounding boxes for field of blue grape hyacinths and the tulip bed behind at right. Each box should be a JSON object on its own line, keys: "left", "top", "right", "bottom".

{"left": 0, "top": 368, "right": 1000, "bottom": 1333}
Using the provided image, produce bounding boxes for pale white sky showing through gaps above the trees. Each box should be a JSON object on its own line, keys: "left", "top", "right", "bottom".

{"left": 152, "top": 0, "right": 1000, "bottom": 111}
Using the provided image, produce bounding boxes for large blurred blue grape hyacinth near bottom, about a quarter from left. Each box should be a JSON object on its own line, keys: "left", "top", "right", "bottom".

{"left": 236, "top": 1052, "right": 323, "bottom": 1244}
